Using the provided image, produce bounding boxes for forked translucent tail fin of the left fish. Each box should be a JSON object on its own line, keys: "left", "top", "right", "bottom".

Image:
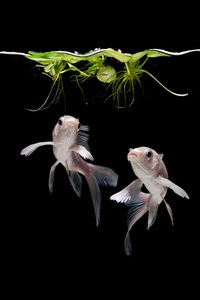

{"left": 85, "top": 164, "right": 118, "bottom": 226}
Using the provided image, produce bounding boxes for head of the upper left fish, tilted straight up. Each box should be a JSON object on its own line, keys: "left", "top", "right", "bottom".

{"left": 53, "top": 115, "right": 80, "bottom": 139}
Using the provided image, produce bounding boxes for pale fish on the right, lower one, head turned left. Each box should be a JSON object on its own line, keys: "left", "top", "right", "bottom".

{"left": 110, "top": 147, "right": 189, "bottom": 255}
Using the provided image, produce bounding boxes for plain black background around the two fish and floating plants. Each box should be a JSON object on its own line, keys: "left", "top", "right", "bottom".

{"left": 0, "top": 2, "right": 200, "bottom": 299}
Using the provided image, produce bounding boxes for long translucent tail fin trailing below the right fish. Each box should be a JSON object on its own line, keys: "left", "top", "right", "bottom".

{"left": 124, "top": 192, "right": 150, "bottom": 256}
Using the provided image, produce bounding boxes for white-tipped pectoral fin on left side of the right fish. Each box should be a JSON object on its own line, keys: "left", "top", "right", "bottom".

{"left": 110, "top": 179, "right": 143, "bottom": 203}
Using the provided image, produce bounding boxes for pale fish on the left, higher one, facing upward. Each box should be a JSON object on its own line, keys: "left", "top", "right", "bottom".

{"left": 21, "top": 116, "right": 118, "bottom": 226}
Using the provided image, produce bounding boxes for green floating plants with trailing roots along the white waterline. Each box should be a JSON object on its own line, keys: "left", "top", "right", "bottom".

{"left": 0, "top": 48, "right": 200, "bottom": 110}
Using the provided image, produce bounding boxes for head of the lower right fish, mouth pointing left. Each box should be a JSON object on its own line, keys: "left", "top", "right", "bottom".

{"left": 128, "top": 147, "right": 167, "bottom": 178}
